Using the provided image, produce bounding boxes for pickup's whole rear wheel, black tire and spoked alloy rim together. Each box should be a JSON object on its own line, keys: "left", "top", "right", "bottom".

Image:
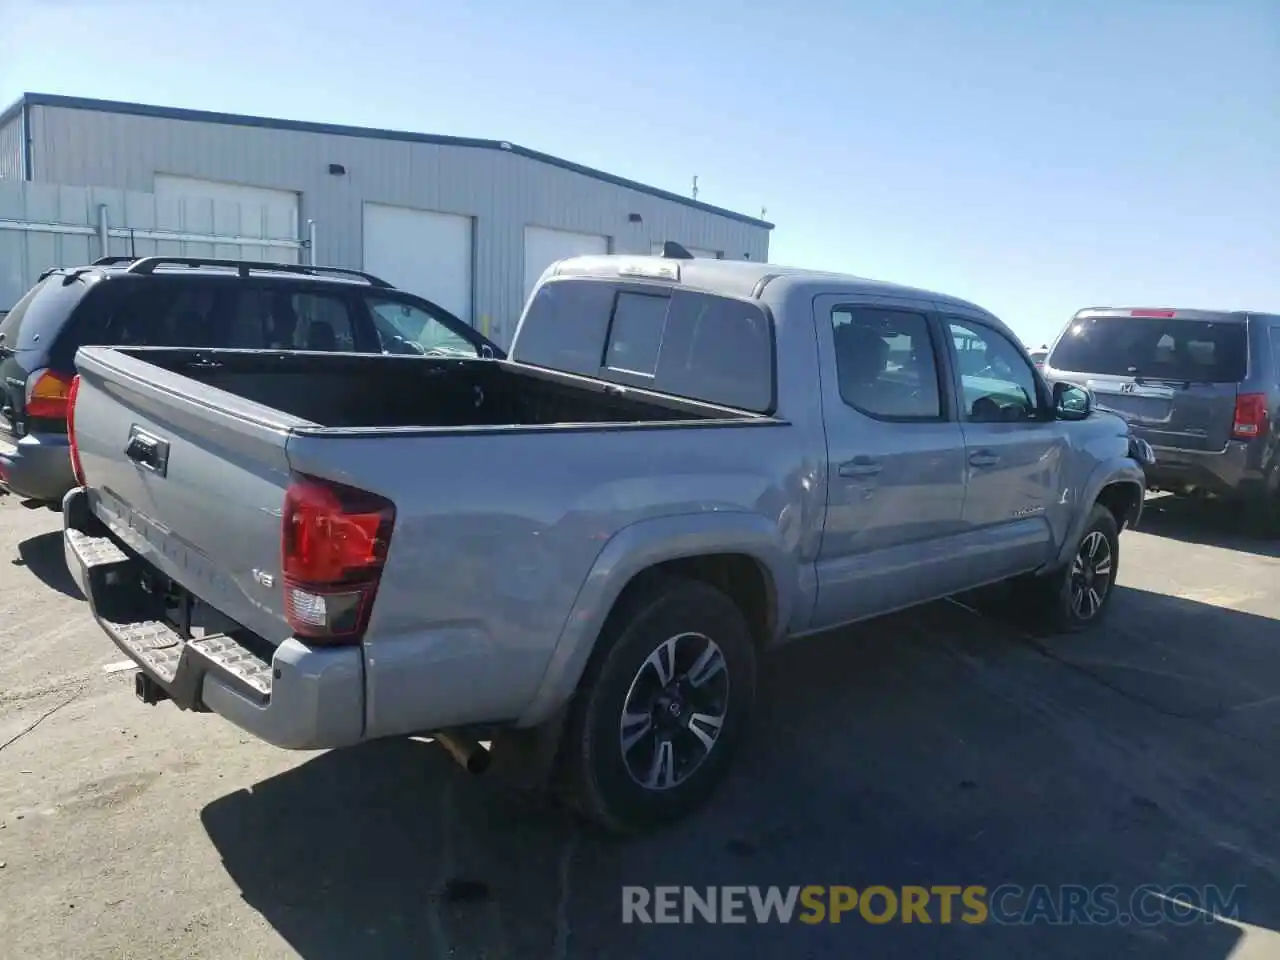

{"left": 563, "top": 580, "right": 755, "bottom": 833}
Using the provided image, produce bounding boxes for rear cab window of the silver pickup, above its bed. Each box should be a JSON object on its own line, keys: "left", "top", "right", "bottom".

{"left": 512, "top": 280, "right": 773, "bottom": 413}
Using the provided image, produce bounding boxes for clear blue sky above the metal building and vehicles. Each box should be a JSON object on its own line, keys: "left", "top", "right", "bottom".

{"left": 0, "top": 0, "right": 1280, "bottom": 346}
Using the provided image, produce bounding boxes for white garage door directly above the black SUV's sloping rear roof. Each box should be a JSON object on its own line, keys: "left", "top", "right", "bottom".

{"left": 365, "top": 204, "right": 472, "bottom": 324}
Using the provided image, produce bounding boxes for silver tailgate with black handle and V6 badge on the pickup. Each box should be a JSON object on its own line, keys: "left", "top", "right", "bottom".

{"left": 76, "top": 347, "right": 307, "bottom": 644}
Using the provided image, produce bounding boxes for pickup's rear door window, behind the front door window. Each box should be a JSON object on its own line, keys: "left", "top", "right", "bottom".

{"left": 831, "top": 307, "right": 942, "bottom": 420}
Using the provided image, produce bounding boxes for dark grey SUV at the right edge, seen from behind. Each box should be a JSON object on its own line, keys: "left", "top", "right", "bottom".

{"left": 1043, "top": 307, "right": 1280, "bottom": 529}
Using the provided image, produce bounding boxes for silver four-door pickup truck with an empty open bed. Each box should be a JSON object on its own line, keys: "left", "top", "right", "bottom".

{"left": 64, "top": 256, "right": 1149, "bottom": 831}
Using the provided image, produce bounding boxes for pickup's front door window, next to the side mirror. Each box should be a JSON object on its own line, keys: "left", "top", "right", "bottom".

{"left": 950, "top": 320, "right": 1039, "bottom": 424}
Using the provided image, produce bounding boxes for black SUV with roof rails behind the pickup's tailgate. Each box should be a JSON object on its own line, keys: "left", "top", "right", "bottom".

{"left": 0, "top": 257, "right": 504, "bottom": 506}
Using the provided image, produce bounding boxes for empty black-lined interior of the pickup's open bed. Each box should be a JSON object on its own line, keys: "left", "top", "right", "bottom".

{"left": 116, "top": 348, "right": 758, "bottom": 429}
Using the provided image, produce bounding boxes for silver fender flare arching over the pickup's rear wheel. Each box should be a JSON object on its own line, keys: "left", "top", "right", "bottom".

{"left": 517, "top": 511, "right": 796, "bottom": 727}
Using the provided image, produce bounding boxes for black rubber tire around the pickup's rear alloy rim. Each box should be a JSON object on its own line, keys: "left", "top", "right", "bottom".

{"left": 561, "top": 579, "right": 756, "bottom": 833}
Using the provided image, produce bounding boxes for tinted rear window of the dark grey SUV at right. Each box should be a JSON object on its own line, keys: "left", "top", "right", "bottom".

{"left": 1050, "top": 316, "right": 1248, "bottom": 383}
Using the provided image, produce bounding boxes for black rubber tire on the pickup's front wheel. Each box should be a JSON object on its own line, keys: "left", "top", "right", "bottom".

{"left": 1018, "top": 503, "right": 1120, "bottom": 634}
